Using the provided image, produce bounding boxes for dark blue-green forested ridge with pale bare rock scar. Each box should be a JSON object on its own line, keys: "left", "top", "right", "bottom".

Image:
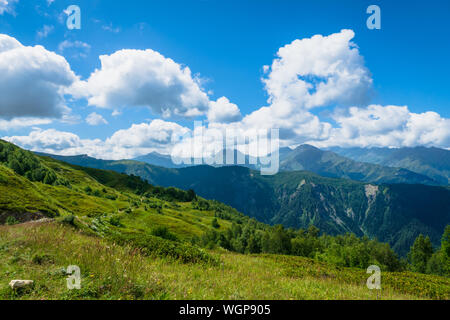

{"left": 37, "top": 151, "right": 450, "bottom": 255}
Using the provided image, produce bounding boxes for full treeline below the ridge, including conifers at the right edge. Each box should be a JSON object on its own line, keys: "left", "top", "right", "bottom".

{"left": 196, "top": 214, "right": 450, "bottom": 276}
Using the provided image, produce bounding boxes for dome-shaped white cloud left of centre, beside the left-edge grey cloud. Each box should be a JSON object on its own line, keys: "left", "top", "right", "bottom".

{"left": 70, "top": 49, "right": 209, "bottom": 117}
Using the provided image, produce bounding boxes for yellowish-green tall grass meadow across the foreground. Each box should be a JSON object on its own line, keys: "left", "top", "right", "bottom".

{"left": 0, "top": 223, "right": 450, "bottom": 300}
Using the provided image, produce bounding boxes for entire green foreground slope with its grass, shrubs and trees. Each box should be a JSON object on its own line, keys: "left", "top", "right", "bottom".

{"left": 0, "top": 141, "right": 450, "bottom": 299}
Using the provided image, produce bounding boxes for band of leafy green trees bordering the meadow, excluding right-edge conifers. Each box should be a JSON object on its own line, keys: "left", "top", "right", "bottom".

{"left": 193, "top": 219, "right": 406, "bottom": 271}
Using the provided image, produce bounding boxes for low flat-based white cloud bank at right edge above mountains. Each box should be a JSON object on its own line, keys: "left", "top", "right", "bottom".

{"left": 310, "top": 105, "right": 450, "bottom": 148}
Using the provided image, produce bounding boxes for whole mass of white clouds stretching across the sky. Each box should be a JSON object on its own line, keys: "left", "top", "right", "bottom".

{"left": 0, "top": 29, "right": 450, "bottom": 159}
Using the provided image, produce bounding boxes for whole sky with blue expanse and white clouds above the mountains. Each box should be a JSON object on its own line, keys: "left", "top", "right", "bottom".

{"left": 0, "top": 0, "right": 450, "bottom": 159}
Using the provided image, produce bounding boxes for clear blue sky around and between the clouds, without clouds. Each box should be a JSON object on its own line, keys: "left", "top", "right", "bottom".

{"left": 0, "top": 0, "right": 450, "bottom": 158}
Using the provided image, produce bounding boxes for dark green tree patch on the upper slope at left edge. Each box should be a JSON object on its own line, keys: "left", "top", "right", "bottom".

{"left": 0, "top": 140, "right": 69, "bottom": 186}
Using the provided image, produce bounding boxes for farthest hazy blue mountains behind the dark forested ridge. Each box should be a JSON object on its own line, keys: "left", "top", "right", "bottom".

{"left": 130, "top": 145, "right": 450, "bottom": 185}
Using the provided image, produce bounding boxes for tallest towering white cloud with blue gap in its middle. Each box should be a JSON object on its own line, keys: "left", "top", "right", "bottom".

{"left": 263, "top": 30, "right": 372, "bottom": 109}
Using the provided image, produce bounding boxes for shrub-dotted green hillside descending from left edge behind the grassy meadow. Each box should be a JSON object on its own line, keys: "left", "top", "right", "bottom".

{"left": 0, "top": 141, "right": 248, "bottom": 245}
